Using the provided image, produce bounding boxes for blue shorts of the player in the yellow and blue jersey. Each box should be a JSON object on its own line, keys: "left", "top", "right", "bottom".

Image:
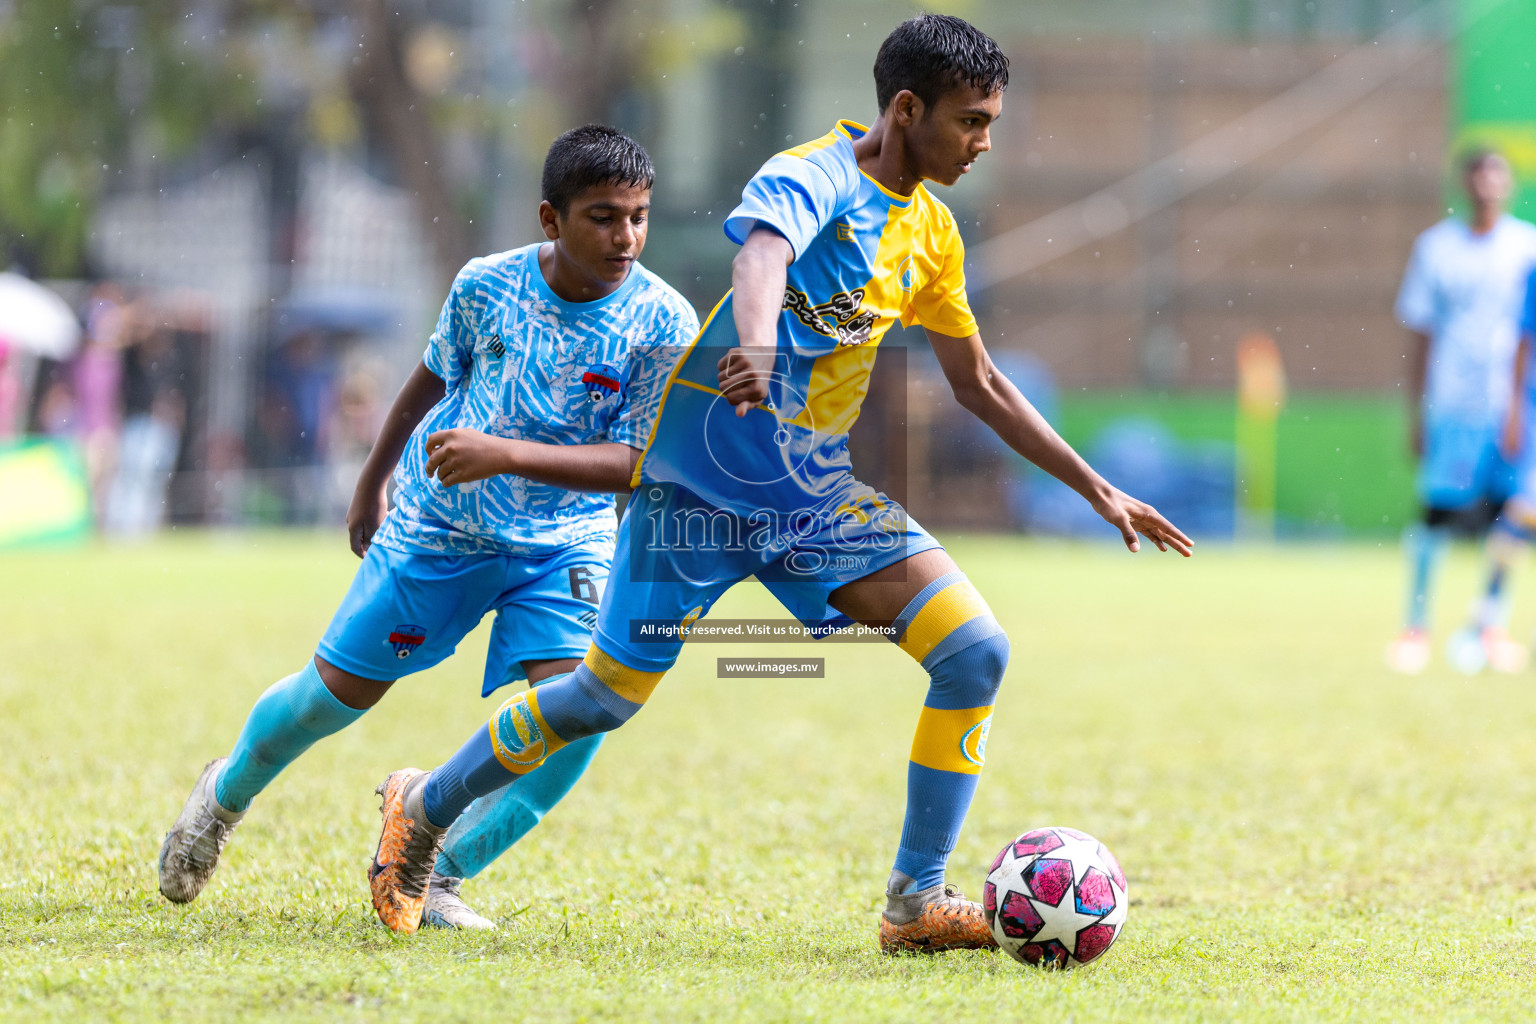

{"left": 593, "top": 484, "right": 943, "bottom": 672}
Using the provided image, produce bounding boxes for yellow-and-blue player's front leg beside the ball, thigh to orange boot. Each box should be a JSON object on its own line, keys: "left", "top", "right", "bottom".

{"left": 828, "top": 548, "right": 1008, "bottom": 952}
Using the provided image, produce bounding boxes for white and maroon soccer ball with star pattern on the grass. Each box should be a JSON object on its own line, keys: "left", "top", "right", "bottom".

{"left": 982, "top": 827, "right": 1129, "bottom": 969}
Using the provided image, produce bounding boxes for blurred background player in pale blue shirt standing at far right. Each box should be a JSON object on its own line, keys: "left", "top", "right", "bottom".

{"left": 1387, "top": 149, "right": 1536, "bottom": 674}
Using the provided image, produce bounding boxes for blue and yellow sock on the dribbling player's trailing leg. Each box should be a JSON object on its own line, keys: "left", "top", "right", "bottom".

{"left": 422, "top": 648, "right": 662, "bottom": 827}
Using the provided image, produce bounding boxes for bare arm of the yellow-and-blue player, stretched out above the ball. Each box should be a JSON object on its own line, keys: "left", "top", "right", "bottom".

{"left": 928, "top": 330, "right": 1193, "bottom": 557}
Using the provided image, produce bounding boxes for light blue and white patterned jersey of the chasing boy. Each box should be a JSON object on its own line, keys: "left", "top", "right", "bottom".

{"left": 373, "top": 244, "right": 699, "bottom": 556}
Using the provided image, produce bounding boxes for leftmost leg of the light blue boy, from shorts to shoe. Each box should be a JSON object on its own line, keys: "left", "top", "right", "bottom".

{"left": 160, "top": 545, "right": 502, "bottom": 903}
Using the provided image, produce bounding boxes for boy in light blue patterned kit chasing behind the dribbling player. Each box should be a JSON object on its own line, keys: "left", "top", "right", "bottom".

{"left": 160, "top": 126, "right": 699, "bottom": 927}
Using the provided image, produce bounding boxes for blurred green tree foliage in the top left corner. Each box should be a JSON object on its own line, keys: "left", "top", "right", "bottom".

{"left": 0, "top": 0, "right": 255, "bottom": 276}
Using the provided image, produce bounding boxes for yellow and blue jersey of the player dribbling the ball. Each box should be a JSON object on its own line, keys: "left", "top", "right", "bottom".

{"left": 634, "top": 121, "right": 975, "bottom": 514}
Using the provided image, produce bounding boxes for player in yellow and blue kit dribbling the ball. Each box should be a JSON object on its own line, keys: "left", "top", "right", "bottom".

{"left": 370, "top": 15, "right": 1189, "bottom": 952}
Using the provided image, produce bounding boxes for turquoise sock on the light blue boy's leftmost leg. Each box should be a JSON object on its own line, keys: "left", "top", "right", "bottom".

{"left": 214, "top": 659, "right": 364, "bottom": 811}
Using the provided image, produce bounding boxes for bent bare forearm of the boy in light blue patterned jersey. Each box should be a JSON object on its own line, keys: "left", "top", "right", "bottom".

{"left": 425, "top": 427, "right": 641, "bottom": 494}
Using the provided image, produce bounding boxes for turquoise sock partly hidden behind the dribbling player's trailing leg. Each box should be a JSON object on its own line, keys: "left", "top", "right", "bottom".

{"left": 438, "top": 732, "right": 602, "bottom": 878}
